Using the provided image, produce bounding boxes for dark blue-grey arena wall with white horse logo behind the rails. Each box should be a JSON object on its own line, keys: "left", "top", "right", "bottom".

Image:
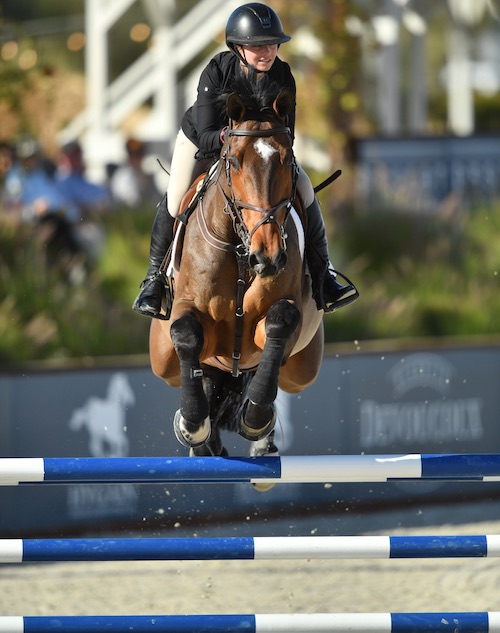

{"left": 0, "top": 345, "right": 500, "bottom": 537}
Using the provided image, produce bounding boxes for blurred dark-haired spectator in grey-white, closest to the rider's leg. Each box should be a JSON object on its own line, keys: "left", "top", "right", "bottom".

{"left": 110, "top": 139, "right": 161, "bottom": 208}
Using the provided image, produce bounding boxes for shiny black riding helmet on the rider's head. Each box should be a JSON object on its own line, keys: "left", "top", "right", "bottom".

{"left": 226, "top": 2, "right": 292, "bottom": 64}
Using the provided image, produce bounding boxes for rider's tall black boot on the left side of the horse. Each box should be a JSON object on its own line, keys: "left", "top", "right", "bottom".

{"left": 132, "top": 195, "right": 175, "bottom": 320}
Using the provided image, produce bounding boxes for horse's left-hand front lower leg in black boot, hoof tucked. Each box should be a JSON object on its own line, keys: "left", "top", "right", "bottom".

{"left": 170, "top": 312, "right": 211, "bottom": 448}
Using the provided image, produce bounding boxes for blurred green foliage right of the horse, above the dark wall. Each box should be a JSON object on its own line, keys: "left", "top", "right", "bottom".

{"left": 326, "top": 204, "right": 500, "bottom": 341}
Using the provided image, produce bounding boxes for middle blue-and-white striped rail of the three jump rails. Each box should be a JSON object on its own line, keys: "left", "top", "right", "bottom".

{"left": 0, "top": 535, "right": 500, "bottom": 564}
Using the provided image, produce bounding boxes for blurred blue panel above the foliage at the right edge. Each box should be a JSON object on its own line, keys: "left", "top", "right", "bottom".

{"left": 353, "top": 134, "right": 500, "bottom": 214}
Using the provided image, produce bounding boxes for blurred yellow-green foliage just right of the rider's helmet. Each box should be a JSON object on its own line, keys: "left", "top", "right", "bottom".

{"left": 273, "top": 0, "right": 367, "bottom": 164}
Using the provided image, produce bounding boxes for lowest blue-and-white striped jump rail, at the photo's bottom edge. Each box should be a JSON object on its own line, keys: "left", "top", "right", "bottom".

{"left": 0, "top": 612, "right": 500, "bottom": 633}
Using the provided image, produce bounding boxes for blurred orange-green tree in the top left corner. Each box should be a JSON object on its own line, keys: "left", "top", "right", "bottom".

{"left": 0, "top": 0, "right": 84, "bottom": 151}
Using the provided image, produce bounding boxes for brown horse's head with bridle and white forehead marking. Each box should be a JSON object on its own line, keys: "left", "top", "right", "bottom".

{"left": 222, "top": 83, "right": 297, "bottom": 277}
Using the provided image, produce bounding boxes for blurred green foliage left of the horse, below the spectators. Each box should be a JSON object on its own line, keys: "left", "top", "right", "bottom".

{"left": 0, "top": 210, "right": 153, "bottom": 364}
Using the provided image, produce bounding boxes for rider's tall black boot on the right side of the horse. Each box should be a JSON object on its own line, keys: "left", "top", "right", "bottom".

{"left": 306, "top": 196, "right": 359, "bottom": 312}
